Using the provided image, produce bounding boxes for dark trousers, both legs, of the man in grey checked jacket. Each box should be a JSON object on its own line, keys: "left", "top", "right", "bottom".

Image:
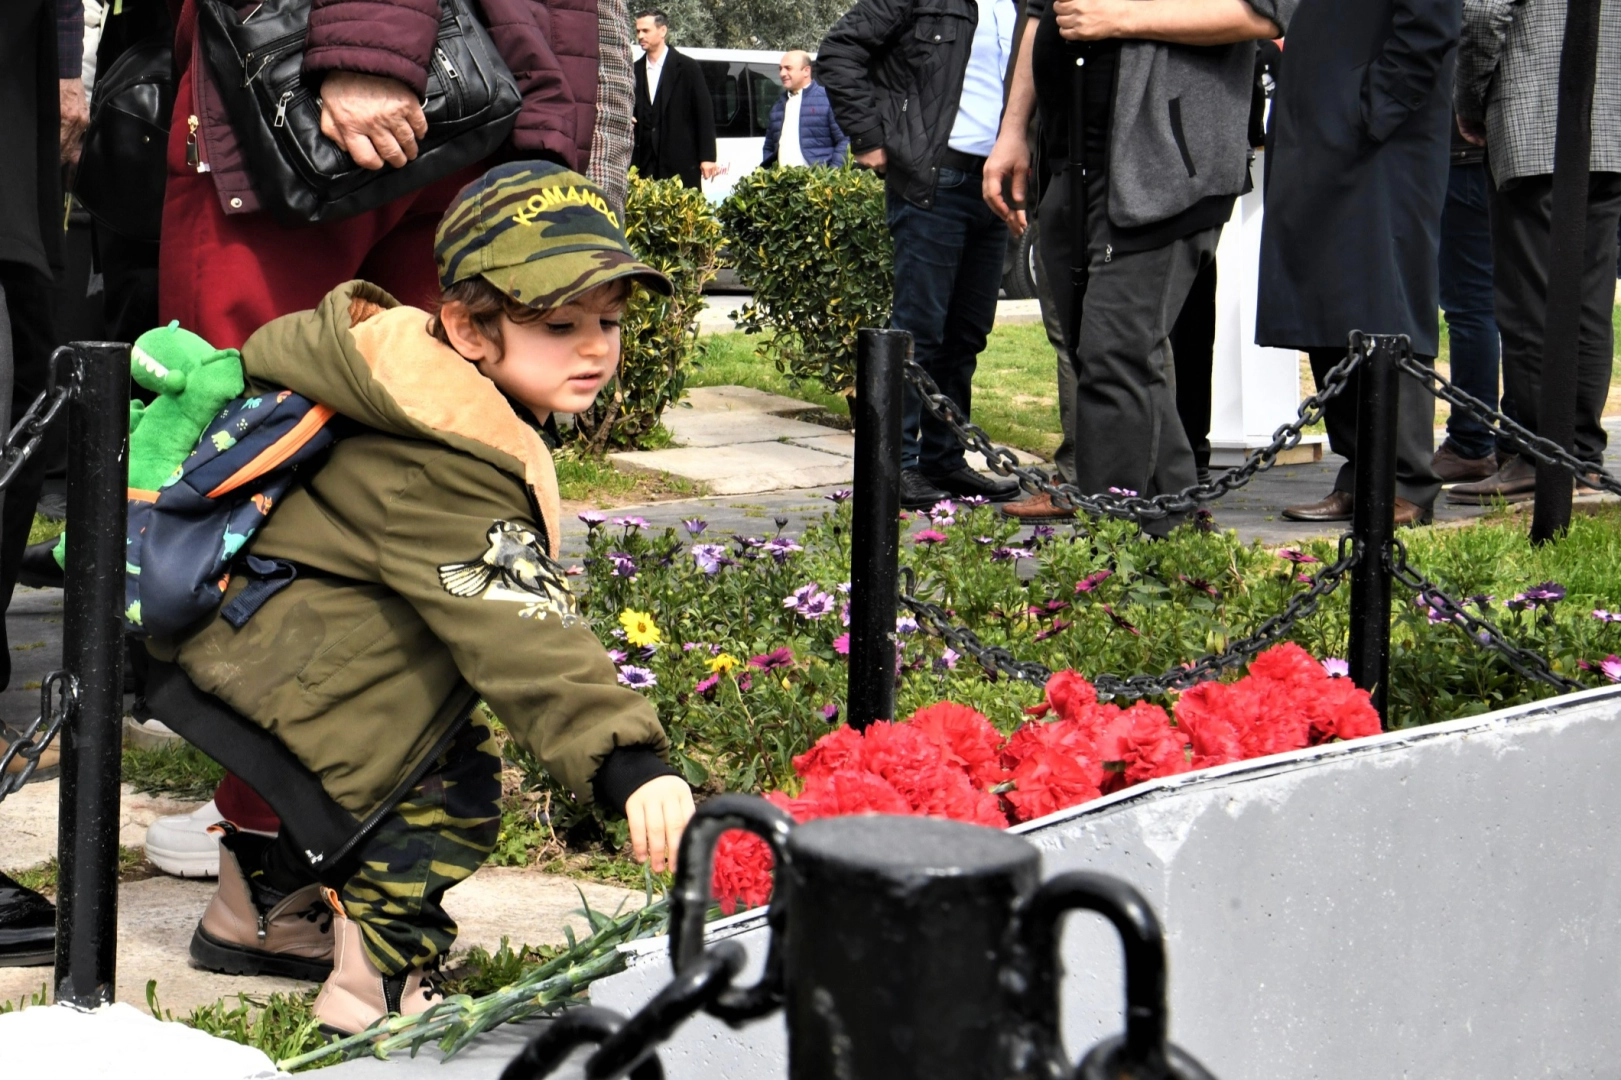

{"left": 1491, "top": 172, "right": 1621, "bottom": 465}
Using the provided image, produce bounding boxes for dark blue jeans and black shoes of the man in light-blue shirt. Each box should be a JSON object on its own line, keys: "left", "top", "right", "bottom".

{"left": 887, "top": 169, "right": 1008, "bottom": 477}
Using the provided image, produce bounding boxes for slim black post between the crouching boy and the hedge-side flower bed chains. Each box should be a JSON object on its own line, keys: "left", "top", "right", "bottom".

{"left": 845, "top": 329, "right": 911, "bottom": 730}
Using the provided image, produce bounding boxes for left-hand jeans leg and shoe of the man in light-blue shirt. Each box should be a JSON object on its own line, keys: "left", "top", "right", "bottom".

{"left": 887, "top": 178, "right": 968, "bottom": 469}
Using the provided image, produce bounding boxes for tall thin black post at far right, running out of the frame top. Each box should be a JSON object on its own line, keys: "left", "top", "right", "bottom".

{"left": 1530, "top": 0, "right": 1600, "bottom": 543}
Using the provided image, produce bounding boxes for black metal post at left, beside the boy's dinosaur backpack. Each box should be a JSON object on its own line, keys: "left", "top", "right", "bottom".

{"left": 55, "top": 342, "right": 130, "bottom": 1009}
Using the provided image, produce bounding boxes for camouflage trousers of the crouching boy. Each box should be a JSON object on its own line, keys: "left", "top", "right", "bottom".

{"left": 340, "top": 715, "right": 501, "bottom": 975}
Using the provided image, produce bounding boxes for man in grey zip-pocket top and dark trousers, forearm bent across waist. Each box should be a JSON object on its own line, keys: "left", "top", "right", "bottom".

{"left": 984, "top": 0, "right": 1298, "bottom": 532}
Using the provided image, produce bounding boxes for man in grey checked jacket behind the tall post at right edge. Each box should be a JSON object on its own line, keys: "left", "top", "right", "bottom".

{"left": 1448, "top": 0, "right": 1621, "bottom": 503}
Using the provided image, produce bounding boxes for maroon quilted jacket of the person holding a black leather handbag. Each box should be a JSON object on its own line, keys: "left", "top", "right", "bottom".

{"left": 175, "top": 0, "right": 598, "bottom": 214}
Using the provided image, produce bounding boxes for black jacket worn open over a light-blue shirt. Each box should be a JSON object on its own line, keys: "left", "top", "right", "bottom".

{"left": 815, "top": 0, "right": 979, "bottom": 209}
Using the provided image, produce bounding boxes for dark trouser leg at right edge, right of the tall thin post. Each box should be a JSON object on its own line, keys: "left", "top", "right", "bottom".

{"left": 1576, "top": 172, "right": 1621, "bottom": 469}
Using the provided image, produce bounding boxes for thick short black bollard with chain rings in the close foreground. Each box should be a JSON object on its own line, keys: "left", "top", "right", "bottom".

{"left": 778, "top": 816, "right": 1041, "bottom": 1080}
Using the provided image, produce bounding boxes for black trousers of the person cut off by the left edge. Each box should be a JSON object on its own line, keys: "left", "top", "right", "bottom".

{"left": 0, "top": 263, "right": 56, "bottom": 689}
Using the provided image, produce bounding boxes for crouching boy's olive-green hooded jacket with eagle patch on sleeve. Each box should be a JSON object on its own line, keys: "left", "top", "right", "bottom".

{"left": 151, "top": 282, "right": 668, "bottom": 821}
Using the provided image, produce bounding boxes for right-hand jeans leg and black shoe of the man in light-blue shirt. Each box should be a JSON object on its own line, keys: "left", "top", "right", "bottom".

{"left": 917, "top": 170, "right": 1008, "bottom": 476}
